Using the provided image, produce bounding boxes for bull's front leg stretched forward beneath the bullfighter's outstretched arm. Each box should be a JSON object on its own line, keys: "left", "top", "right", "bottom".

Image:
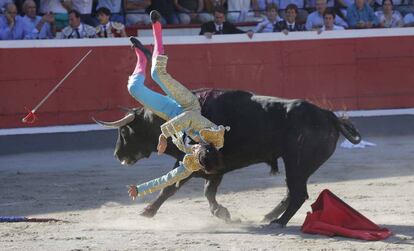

{"left": 141, "top": 161, "right": 192, "bottom": 218}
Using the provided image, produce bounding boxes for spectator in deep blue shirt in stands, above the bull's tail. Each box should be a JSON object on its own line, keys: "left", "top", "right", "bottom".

{"left": 346, "top": 0, "right": 379, "bottom": 29}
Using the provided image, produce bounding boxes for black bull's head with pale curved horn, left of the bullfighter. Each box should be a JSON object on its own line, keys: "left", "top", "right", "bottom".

{"left": 94, "top": 108, "right": 160, "bottom": 166}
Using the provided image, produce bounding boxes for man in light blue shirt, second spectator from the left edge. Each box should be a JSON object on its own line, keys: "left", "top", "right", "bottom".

{"left": 23, "top": 0, "right": 56, "bottom": 39}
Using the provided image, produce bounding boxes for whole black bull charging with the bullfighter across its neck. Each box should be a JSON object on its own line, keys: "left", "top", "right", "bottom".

{"left": 97, "top": 89, "right": 361, "bottom": 225}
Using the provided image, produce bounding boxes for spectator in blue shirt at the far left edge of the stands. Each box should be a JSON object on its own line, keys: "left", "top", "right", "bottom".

{"left": 0, "top": 3, "right": 28, "bottom": 40}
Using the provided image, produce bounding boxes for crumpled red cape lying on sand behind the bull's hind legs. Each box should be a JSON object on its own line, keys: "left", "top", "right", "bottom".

{"left": 302, "top": 189, "right": 392, "bottom": 241}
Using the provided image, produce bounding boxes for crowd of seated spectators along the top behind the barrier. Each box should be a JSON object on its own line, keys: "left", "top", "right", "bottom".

{"left": 0, "top": 0, "right": 414, "bottom": 40}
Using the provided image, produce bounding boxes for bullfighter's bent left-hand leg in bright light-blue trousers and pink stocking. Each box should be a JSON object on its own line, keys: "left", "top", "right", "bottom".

{"left": 128, "top": 37, "right": 182, "bottom": 120}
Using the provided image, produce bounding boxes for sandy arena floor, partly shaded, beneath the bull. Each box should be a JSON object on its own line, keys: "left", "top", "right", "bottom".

{"left": 0, "top": 136, "right": 414, "bottom": 250}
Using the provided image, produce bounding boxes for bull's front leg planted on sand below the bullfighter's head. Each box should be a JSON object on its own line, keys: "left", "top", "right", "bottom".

{"left": 204, "top": 175, "right": 231, "bottom": 221}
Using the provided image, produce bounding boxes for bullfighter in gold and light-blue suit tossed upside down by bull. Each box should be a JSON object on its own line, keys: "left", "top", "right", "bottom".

{"left": 128, "top": 11, "right": 230, "bottom": 199}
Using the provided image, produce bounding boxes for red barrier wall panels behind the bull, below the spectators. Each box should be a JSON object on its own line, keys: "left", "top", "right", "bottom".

{"left": 0, "top": 32, "right": 414, "bottom": 128}
